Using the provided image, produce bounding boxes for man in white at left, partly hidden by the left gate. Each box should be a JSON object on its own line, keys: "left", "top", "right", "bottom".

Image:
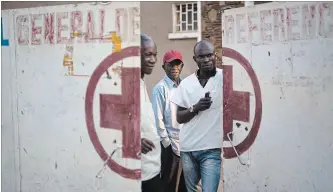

{"left": 140, "top": 34, "right": 164, "bottom": 192}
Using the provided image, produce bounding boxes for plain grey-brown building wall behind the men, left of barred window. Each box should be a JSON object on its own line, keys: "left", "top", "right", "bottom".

{"left": 140, "top": 1, "right": 197, "bottom": 95}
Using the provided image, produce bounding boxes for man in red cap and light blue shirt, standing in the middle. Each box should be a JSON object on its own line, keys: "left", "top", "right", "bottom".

{"left": 152, "top": 50, "right": 187, "bottom": 192}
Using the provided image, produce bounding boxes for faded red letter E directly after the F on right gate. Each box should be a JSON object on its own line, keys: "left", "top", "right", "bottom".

{"left": 260, "top": 10, "right": 272, "bottom": 42}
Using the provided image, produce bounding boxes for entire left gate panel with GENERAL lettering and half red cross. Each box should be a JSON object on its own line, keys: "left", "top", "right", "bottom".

{"left": 2, "top": 2, "right": 141, "bottom": 192}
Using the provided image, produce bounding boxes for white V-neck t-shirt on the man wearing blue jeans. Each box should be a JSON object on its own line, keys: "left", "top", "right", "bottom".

{"left": 171, "top": 69, "right": 223, "bottom": 152}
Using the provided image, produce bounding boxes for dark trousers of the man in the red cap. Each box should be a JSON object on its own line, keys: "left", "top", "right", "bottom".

{"left": 161, "top": 145, "right": 187, "bottom": 192}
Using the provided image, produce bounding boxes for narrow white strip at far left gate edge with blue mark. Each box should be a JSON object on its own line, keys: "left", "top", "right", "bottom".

{"left": 1, "top": 11, "right": 19, "bottom": 191}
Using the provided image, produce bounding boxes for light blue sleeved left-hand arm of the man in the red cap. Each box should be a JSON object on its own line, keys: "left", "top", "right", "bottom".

{"left": 152, "top": 88, "right": 171, "bottom": 148}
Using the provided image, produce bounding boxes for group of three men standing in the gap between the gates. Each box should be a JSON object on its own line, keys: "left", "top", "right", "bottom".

{"left": 140, "top": 35, "right": 223, "bottom": 192}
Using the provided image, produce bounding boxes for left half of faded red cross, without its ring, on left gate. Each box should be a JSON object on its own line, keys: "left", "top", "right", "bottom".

{"left": 100, "top": 68, "right": 140, "bottom": 159}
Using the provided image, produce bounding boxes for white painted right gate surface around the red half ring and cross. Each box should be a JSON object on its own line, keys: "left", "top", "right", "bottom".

{"left": 222, "top": 2, "right": 333, "bottom": 192}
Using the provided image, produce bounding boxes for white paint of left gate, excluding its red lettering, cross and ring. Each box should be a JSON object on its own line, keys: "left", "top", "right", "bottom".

{"left": 1, "top": 2, "right": 141, "bottom": 192}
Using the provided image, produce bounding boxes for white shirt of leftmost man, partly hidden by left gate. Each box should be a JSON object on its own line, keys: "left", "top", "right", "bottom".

{"left": 140, "top": 79, "right": 161, "bottom": 181}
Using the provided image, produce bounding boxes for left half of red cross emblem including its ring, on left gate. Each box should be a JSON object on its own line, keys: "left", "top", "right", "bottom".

{"left": 85, "top": 46, "right": 141, "bottom": 180}
